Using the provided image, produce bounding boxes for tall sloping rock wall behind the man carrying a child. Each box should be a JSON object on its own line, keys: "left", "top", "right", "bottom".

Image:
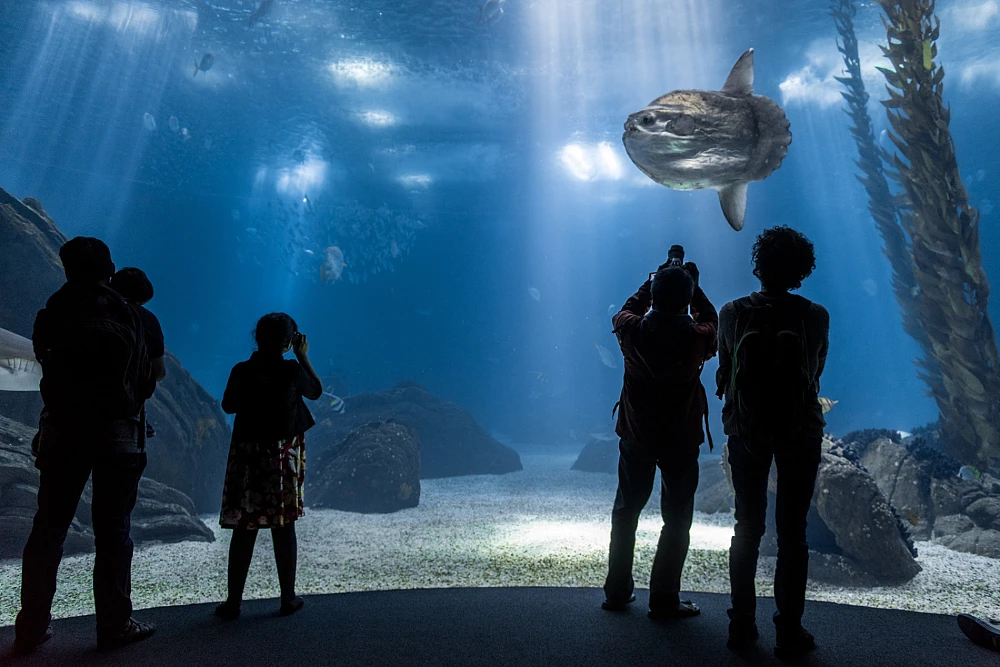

{"left": 0, "top": 189, "right": 229, "bottom": 512}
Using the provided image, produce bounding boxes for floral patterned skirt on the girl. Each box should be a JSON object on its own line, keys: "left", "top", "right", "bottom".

{"left": 219, "top": 433, "right": 306, "bottom": 530}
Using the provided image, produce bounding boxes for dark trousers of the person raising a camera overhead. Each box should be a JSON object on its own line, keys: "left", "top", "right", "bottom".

{"left": 604, "top": 440, "right": 698, "bottom": 609}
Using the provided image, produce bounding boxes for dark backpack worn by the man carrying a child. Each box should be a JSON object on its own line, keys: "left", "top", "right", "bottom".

{"left": 43, "top": 289, "right": 156, "bottom": 421}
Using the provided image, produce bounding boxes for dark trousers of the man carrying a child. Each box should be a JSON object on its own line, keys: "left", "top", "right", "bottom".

{"left": 16, "top": 446, "right": 146, "bottom": 641}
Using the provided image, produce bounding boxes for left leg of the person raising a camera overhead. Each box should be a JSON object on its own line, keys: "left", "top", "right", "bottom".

{"left": 604, "top": 440, "right": 656, "bottom": 606}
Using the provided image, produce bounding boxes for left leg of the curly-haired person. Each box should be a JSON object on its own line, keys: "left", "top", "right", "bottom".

{"left": 728, "top": 436, "right": 771, "bottom": 627}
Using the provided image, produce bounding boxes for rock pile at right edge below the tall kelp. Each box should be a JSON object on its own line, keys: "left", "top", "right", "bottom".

{"left": 843, "top": 430, "right": 1000, "bottom": 558}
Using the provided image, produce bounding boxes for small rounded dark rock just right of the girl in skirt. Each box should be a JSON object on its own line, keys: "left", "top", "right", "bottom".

{"left": 305, "top": 420, "right": 420, "bottom": 514}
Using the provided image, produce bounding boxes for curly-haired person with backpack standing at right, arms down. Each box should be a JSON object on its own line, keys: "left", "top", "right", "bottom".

{"left": 717, "top": 227, "right": 830, "bottom": 657}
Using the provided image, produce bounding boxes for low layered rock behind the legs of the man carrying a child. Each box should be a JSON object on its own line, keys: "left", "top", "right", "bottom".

{"left": 0, "top": 417, "right": 215, "bottom": 558}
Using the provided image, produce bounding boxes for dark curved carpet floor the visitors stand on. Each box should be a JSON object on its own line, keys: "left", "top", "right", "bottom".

{"left": 0, "top": 588, "right": 1000, "bottom": 667}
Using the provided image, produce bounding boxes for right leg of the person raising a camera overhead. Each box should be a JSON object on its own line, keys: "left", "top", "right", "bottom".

{"left": 649, "top": 449, "right": 699, "bottom": 612}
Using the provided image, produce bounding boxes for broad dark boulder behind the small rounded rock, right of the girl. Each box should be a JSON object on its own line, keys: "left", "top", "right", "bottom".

{"left": 306, "top": 382, "right": 523, "bottom": 479}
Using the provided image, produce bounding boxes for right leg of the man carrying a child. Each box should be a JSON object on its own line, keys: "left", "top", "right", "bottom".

{"left": 91, "top": 454, "right": 146, "bottom": 636}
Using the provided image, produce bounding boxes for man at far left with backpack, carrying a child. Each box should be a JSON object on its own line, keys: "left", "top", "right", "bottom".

{"left": 15, "top": 237, "right": 155, "bottom": 652}
